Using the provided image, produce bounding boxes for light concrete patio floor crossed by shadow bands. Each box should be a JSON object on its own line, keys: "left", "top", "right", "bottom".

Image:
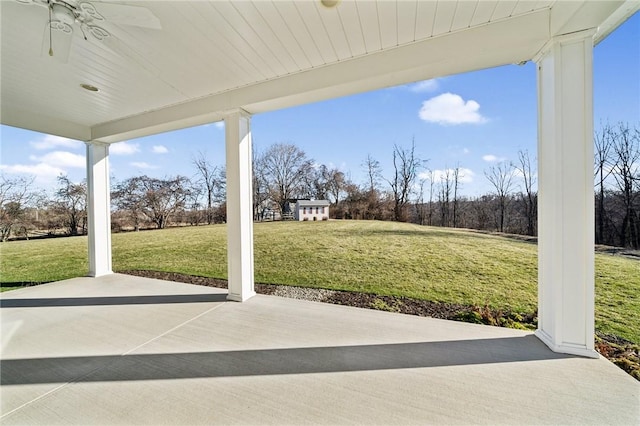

{"left": 0, "top": 274, "right": 640, "bottom": 425}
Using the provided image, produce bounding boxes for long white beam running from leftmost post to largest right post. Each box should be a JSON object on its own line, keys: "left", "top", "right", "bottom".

{"left": 91, "top": 9, "right": 550, "bottom": 142}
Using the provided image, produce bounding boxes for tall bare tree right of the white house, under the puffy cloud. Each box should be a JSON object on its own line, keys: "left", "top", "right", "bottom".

{"left": 387, "top": 141, "right": 422, "bottom": 222}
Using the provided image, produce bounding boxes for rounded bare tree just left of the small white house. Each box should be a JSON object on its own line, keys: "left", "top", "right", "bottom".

{"left": 262, "top": 144, "right": 312, "bottom": 211}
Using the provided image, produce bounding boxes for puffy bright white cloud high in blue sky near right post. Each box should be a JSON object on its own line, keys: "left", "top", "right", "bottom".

{"left": 418, "top": 93, "right": 487, "bottom": 125}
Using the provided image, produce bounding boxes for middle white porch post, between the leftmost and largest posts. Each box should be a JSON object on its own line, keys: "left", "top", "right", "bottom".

{"left": 224, "top": 110, "right": 256, "bottom": 302}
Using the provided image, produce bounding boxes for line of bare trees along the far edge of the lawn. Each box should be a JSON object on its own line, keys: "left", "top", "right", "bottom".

{"left": 0, "top": 123, "right": 640, "bottom": 249}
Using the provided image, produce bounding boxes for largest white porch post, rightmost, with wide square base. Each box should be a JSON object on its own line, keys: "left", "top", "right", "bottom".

{"left": 536, "top": 30, "right": 598, "bottom": 357}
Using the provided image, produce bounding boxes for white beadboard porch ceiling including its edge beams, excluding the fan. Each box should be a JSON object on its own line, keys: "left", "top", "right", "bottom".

{"left": 0, "top": 0, "right": 640, "bottom": 142}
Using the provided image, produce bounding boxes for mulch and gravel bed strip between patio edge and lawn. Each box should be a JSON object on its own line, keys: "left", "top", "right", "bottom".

{"left": 118, "top": 271, "right": 640, "bottom": 381}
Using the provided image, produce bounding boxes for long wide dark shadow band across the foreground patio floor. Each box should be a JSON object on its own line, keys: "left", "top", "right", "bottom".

{"left": 1, "top": 335, "right": 569, "bottom": 386}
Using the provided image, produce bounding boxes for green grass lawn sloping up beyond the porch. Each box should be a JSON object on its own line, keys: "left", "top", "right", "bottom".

{"left": 0, "top": 221, "right": 640, "bottom": 343}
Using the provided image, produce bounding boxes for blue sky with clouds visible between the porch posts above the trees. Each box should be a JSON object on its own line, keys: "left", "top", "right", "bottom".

{"left": 0, "top": 13, "right": 640, "bottom": 196}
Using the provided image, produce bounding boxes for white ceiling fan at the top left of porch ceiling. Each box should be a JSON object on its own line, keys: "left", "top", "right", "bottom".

{"left": 16, "top": 0, "right": 161, "bottom": 63}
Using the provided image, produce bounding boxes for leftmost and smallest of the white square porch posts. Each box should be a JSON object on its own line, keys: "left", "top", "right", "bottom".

{"left": 87, "top": 142, "right": 113, "bottom": 277}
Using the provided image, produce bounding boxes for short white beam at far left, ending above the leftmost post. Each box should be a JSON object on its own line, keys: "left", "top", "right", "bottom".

{"left": 0, "top": 106, "right": 91, "bottom": 142}
